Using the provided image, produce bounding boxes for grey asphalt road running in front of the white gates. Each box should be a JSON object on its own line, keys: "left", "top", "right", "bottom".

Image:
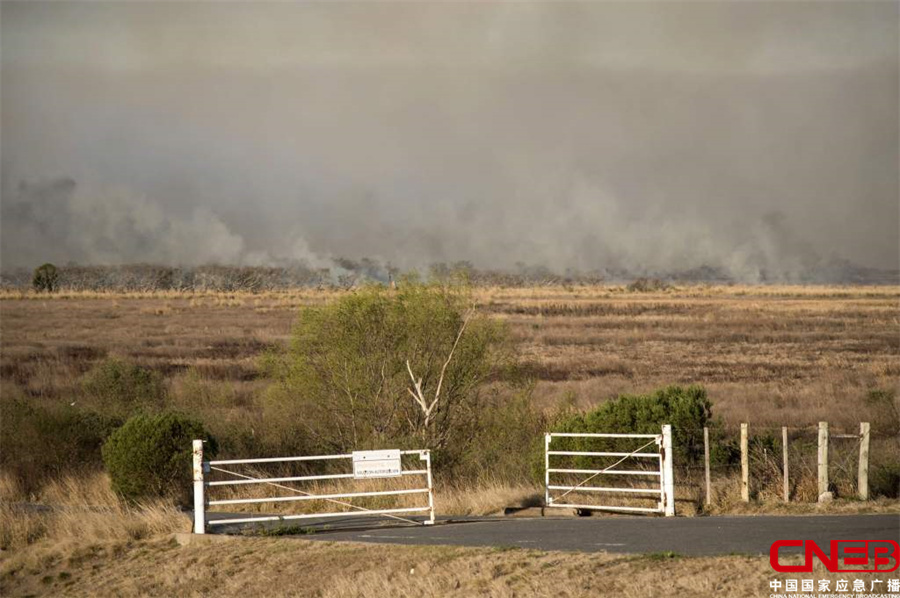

{"left": 210, "top": 513, "right": 900, "bottom": 555}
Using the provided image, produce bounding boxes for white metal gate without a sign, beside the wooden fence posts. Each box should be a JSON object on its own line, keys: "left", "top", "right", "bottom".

{"left": 544, "top": 425, "right": 675, "bottom": 517}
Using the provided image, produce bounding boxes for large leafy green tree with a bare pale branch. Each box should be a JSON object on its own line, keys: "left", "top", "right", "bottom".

{"left": 268, "top": 280, "right": 510, "bottom": 459}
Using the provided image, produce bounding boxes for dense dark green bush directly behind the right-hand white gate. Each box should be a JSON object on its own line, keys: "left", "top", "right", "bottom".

{"left": 554, "top": 386, "right": 712, "bottom": 464}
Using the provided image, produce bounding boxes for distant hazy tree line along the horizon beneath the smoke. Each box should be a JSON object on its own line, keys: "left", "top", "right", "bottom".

{"left": 0, "top": 258, "right": 900, "bottom": 292}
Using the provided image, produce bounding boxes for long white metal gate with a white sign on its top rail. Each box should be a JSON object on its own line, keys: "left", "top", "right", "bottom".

{"left": 193, "top": 440, "right": 434, "bottom": 534}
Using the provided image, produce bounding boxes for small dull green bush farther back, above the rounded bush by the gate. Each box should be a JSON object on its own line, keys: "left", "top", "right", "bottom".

{"left": 81, "top": 358, "right": 166, "bottom": 417}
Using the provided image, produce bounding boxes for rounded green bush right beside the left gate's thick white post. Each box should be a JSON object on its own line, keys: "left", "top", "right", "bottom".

{"left": 103, "top": 411, "right": 217, "bottom": 504}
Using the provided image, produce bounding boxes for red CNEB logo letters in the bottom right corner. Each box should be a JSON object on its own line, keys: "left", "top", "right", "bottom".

{"left": 769, "top": 540, "right": 900, "bottom": 573}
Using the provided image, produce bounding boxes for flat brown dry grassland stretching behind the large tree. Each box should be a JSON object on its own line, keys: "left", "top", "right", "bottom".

{"left": 0, "top": 286, "right": 900, "bottom": 427}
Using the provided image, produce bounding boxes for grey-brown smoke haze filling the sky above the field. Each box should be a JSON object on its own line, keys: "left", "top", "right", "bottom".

{"left": 0, "top": 2, "right": 900, "bottom": 281}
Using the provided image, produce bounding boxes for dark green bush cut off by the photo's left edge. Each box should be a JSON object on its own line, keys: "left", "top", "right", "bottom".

{"left": 0, "top": 397, "right": 122, "bottom": 492}
